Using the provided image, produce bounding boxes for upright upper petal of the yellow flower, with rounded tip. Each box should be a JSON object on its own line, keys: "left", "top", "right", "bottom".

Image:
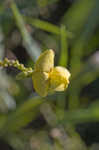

{"left": 34, "top": 49, "right": 54, "bottom": 72}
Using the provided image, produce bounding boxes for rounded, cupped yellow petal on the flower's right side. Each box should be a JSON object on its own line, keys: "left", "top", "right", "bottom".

{"left": 49, "top": 66, "right": 70, "bottom": 92}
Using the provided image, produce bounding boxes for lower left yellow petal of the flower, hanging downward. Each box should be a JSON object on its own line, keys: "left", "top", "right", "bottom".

{"left": 32, "top": 71, "right": 49, "bottom": 97}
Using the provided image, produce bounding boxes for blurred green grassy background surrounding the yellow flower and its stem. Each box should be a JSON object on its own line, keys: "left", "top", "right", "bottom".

{"left": 0, "top": 0, "right": 99, "bottom": 150}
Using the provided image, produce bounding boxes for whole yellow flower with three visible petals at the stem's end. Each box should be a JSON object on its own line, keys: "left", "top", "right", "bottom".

{"left": 32, "top": 50, "right": 70, "bottom": 97}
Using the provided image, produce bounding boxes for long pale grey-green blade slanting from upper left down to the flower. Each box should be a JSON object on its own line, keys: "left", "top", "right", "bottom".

{"left": 10, "top": 1, "right": 40, "bottom": 61}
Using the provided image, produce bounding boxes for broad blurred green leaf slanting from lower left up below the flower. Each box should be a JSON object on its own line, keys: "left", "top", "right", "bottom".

{"left": 6, "top": 96, "right": 45, "bottom": 132}
